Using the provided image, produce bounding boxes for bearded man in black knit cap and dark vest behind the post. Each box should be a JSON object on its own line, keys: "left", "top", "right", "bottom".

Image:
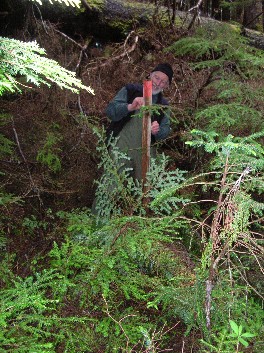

{"left": 106, "top": 63, "right": 173, "bottom": 180}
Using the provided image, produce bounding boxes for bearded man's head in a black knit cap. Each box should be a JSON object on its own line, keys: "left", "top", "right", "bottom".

{"left": 150, "top": 63, "right": 173, "bottom": 94}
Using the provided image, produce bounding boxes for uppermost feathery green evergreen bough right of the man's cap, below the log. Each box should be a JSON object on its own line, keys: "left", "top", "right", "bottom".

{"left": 166, "top": 24, "right": 264, "bottom": 77}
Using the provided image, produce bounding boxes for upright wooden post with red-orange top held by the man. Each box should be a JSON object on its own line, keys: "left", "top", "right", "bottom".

{"left": 142, "top": 80, "right": 152, "bottom": 192}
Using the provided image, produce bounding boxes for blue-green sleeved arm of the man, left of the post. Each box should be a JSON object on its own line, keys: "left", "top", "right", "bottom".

{"left": 106, "top": 87, "right": 129, "bottom": 121}
